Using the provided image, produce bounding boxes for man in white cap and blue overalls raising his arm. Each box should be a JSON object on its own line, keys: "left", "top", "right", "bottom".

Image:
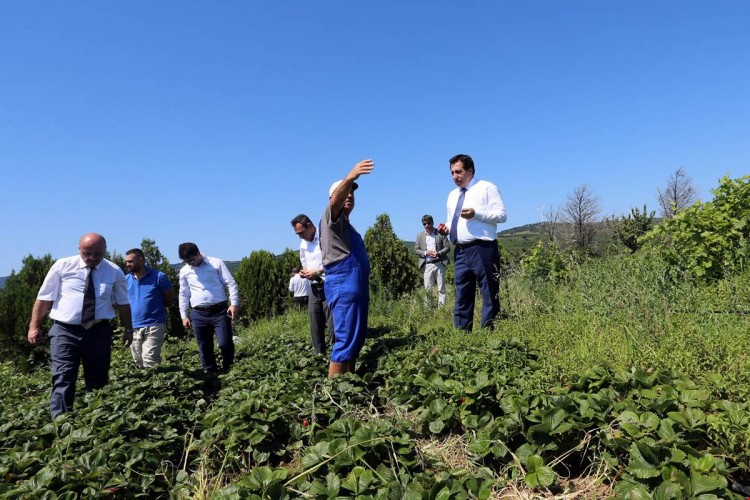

{"left": 320, "top": 160, "right": 375, "bottom": 378}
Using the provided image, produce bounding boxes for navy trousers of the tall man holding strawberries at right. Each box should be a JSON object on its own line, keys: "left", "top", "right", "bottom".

{"left": 453, "top": 240, "right": 500, "bottom": 330}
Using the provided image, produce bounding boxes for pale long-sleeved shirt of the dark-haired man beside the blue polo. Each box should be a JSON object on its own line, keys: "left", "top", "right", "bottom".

{"left": 180, "top": 255, "right": 240, "bottom": 319}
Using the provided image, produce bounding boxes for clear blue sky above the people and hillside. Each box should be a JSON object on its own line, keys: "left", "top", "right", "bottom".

{"left": 0, "top": 0, "right": 750, "bottom": 276}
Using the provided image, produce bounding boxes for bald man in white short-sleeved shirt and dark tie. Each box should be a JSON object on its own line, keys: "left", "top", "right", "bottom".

{"left": 28, "top": 233, "right": 133, "bottom": 418}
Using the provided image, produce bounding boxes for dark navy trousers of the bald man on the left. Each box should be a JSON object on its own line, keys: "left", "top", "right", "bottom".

{"left": 49, "top": 321, "right": 112, "bottom": 418}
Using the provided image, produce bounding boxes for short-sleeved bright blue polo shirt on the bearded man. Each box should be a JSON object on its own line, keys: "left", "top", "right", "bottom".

{"left": 125, "top": 267, "right": 172, "bottom": 328}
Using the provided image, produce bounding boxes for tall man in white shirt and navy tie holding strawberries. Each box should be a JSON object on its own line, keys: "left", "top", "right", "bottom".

{"left": 438, "top": 154, "right": 507, "bottom": 331}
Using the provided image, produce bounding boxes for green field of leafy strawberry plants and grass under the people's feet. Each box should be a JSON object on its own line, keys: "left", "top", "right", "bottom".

{"left": 0, "top": 252, "right": 750, "bottom": 498}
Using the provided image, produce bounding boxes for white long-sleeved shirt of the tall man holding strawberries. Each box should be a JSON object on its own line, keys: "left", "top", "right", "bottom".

{"left": 446, "top": 177, "right": 508, "bottom": 244}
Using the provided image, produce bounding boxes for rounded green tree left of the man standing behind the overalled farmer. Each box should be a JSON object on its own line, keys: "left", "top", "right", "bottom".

{"left": 235, "top": 250, "right": 289, "bottom": 320}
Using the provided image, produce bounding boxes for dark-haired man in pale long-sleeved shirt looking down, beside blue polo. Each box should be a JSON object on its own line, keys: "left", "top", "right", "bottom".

{"left": 178, "top": 243, "right": 240, "bottom": 374}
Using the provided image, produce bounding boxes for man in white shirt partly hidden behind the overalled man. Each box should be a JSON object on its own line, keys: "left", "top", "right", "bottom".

{"left": 292, "top": 214, "right": 333, "bottom": 356}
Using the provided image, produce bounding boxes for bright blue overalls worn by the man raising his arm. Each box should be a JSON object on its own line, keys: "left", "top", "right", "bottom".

{"left": 324, "top": 226, "right": 370, "bottom": 363}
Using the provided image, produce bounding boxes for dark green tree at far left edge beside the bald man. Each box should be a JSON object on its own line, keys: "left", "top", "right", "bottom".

{"left": 0, "top": 254, "right": 54, "bottom": 361}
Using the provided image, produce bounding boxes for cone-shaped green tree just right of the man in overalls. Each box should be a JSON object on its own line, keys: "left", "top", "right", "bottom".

{"left": 365, "top": 214, "right": 419, "bottom": 299}
